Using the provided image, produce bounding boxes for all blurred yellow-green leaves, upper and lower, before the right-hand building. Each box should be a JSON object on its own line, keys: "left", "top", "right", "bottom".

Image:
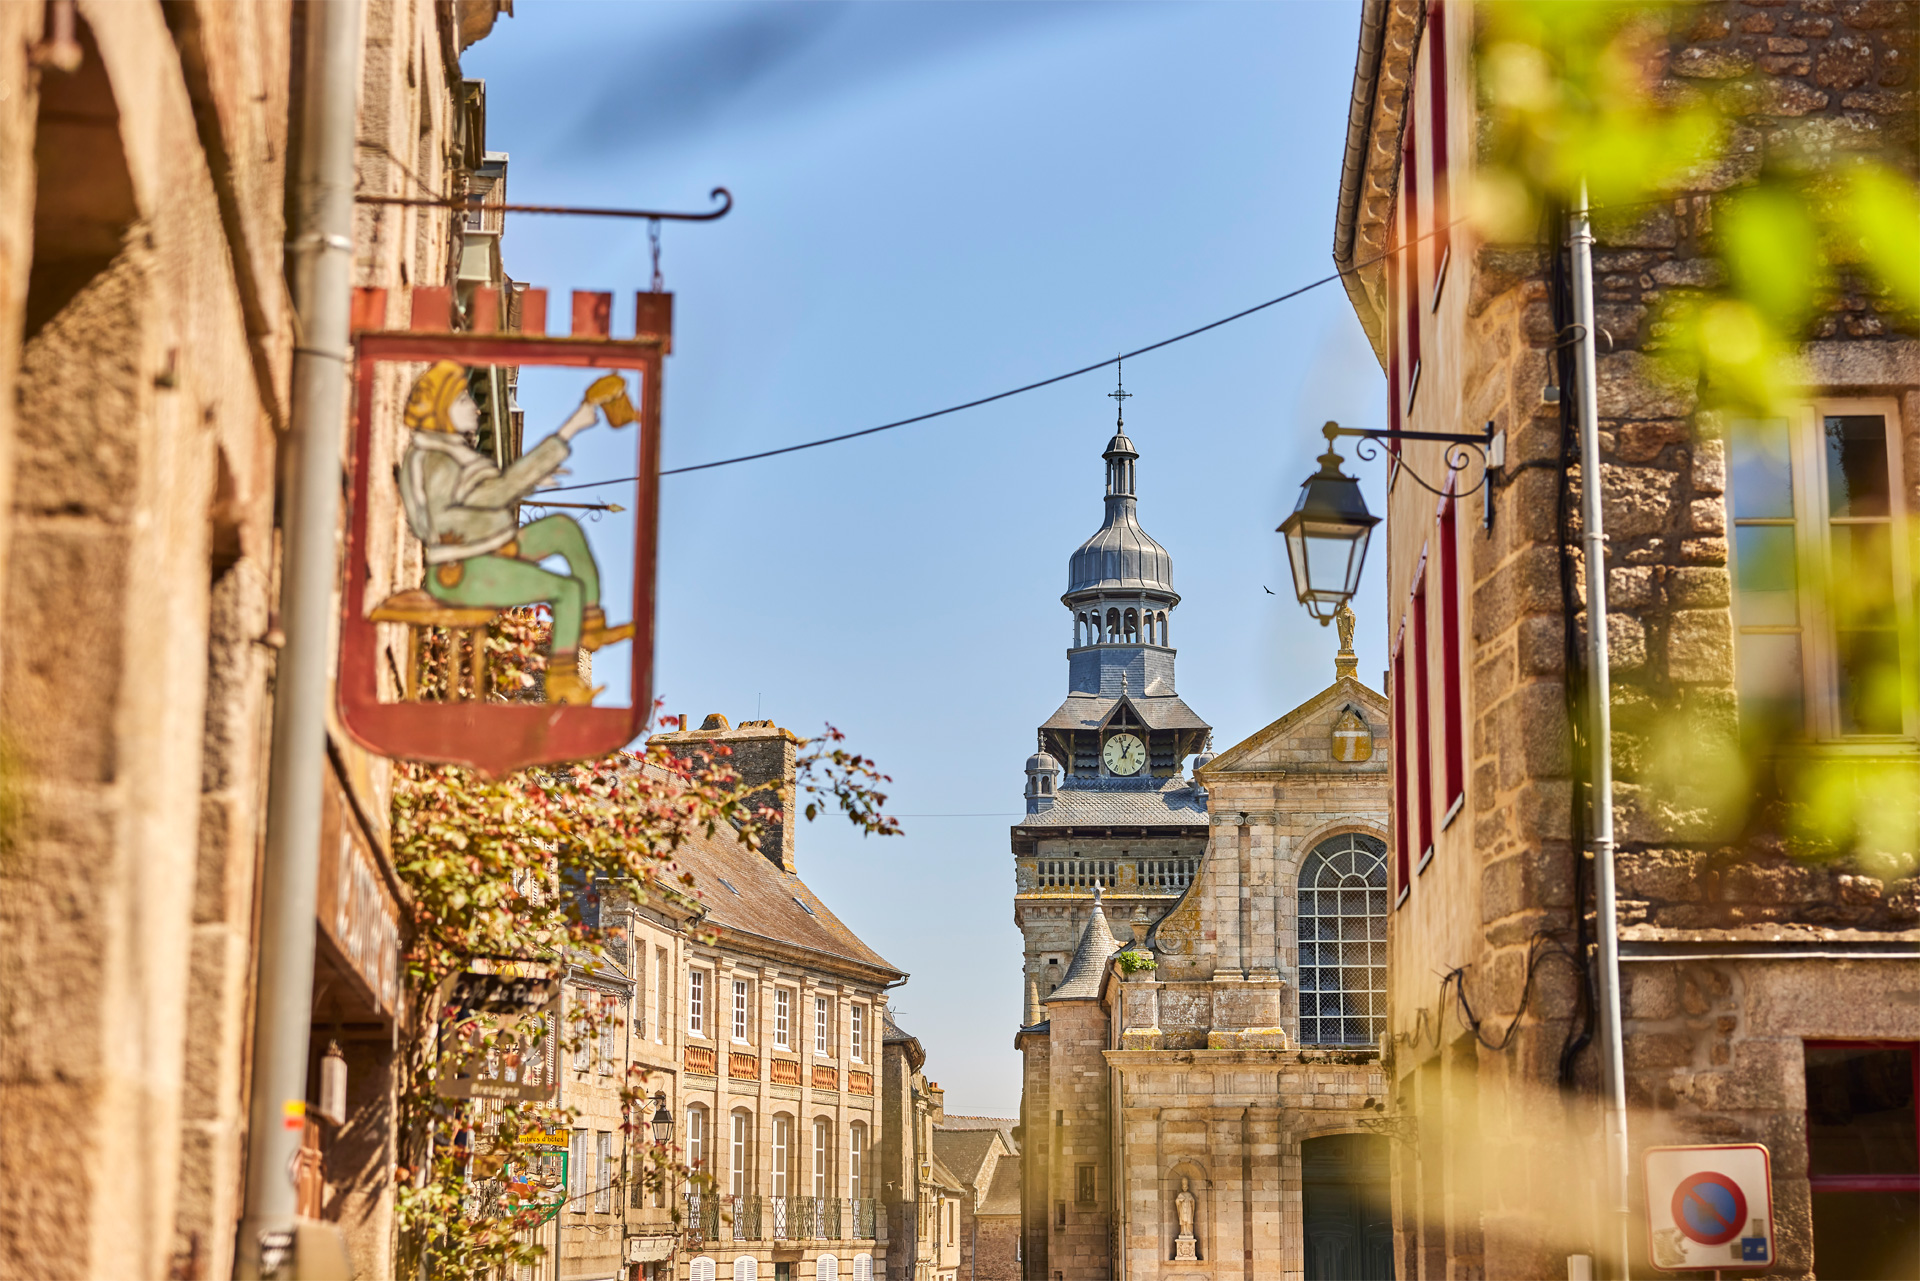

{"left": 1467, "top": 0, "right": 1920, "bottom": 876}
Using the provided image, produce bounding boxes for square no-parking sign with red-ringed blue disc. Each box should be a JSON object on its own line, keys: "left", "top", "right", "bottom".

{"left": 1645, "top": 1143, "right": 1774, "bottom": 1271}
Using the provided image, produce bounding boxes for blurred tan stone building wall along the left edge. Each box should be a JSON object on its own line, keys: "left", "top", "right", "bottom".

{"left": 0, "top": 0, "right": 505, "bottom": 1277}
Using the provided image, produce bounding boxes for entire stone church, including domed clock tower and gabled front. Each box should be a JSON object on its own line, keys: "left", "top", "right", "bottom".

{"left": 1012, "top": 403, "right": 1392, "bottom": 1281}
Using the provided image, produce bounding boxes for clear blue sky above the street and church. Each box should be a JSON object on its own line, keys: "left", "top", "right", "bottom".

{"left": 465, "top": 0, "right": 1384, "bottom": 1116}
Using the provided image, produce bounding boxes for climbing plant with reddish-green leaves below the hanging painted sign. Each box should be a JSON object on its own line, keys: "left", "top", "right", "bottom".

{"left": 392, "top": 611, "right": 900, "bottom": 1281}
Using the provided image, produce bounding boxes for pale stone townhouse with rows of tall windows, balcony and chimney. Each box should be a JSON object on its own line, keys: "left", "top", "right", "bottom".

{"left": 645, "top": 714, "right": 910, "bottom": 1281}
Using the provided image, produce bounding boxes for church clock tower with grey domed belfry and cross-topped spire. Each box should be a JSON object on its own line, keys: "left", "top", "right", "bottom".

{"left": 1012, "top": 390, "right": 1212, "bottom": 1277}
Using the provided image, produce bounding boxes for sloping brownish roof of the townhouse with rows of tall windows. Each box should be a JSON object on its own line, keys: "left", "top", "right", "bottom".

{"left": 674, "top": 828, "right": 906, "bottom": 978}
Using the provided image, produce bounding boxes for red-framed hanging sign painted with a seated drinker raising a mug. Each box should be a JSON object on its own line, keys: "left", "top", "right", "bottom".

{"left": 340, "top": 288, "right": 672, "bottom": 776}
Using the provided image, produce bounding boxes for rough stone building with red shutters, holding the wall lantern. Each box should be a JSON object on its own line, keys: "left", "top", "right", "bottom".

{"left": 1334, "top": 0, "right": 1920, "bottom": 1277}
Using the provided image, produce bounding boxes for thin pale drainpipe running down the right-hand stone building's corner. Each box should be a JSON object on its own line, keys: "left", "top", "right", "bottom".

{"left": 1569, "top": 181, "right": 1630, "bottom": 1281}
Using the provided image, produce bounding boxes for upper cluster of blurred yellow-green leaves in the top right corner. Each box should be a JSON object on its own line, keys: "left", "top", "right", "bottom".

{"left": 1471, "top": 0, "right": 1920, "bottom": 413}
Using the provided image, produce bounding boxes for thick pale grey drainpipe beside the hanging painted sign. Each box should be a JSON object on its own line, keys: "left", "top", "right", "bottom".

{"left": 236, "top": 0, "right": 361, "bottom": 1277}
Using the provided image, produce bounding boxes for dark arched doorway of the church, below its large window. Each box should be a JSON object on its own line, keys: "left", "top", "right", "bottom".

{"left": 1300, "top": 1135, "right": 1394, "bottom": 1281}
